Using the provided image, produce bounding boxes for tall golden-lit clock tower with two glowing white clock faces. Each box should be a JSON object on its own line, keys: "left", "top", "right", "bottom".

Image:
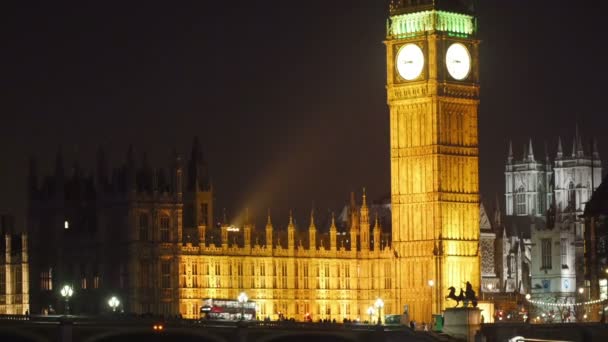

{"left": 386, "top": 0, "right": 480, "bottom": 322}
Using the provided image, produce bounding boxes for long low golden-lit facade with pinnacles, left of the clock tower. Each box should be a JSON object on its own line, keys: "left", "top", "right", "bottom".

{"left": 179, "top": 197, "right": 398, "bottom": 322}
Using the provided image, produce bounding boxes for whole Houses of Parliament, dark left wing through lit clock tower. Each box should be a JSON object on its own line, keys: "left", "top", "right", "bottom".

{"left": 21, "top": 0, "right": 480, "bottom": 322}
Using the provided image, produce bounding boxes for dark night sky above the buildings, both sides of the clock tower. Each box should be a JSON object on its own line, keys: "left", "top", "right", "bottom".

{"left": 0, "top": 0, "right": 608, "bottom": 230}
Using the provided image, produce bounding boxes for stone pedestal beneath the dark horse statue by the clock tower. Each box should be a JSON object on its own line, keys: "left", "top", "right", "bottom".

{"left": 443, "top": 307, "right": 481, "bottom": 342}
